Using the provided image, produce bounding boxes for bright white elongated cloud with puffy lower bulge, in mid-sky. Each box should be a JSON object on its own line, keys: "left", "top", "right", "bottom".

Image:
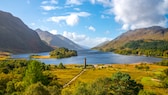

{"left": 47, "top": 12, "right": 90, "bottom": 26}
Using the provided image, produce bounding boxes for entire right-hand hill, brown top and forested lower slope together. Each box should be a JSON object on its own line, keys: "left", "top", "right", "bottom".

{"left": 93, "top": 26, "right": 168, "bottom": 57}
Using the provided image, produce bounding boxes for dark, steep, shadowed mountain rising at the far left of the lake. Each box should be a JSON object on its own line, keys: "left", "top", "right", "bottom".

{"left": 0, "top": 11, "right": 52, "bottom": 53}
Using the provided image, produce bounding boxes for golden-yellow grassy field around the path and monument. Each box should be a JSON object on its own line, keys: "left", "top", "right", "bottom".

{"left": 51, "top": 64, "right": 168, "bottom": 95}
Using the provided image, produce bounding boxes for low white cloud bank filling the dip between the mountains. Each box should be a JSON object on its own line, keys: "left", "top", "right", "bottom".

{"left": 63, "top": 31, "right": 112, "bottom": 48}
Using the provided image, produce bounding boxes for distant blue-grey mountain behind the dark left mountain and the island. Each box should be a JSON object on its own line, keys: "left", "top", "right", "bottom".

{"left": 35, "top": 29, "right": 82, "bottom": 50}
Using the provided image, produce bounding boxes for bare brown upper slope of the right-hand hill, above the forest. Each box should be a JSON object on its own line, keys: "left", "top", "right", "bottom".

{"left": 94, "top": 26, "right": 168, "bottom": 51}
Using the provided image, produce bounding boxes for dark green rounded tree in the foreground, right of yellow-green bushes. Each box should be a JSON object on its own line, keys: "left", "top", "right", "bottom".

{"left": 110, "top": 72, "right": 143, "bottom": 95}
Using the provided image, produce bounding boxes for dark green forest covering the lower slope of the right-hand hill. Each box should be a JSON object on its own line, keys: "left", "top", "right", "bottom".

{"left": 113, "top": 40, "right": 168, "bottom": 58}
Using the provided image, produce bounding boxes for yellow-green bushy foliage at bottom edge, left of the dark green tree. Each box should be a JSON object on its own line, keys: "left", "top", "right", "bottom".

{"left": 72, "top": 78, "right": 111, "bottom": 95}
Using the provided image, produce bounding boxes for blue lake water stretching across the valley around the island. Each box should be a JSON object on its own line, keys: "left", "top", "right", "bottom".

{"left": 11, "top": 50, "right": 162, "bottom": 64}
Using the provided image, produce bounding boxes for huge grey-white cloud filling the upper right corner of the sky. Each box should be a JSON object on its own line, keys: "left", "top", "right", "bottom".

{"left": 111, "top": 0, "right": 168, "bottom": 30}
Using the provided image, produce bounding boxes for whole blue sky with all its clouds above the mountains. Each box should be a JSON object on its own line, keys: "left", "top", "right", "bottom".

{"left": 0, "top": 0, "right": 168, "bottom": 47}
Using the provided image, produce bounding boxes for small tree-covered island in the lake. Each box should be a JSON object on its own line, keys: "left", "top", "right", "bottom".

{"left": 50, "top": 48, "right": 77, "bottom": 59}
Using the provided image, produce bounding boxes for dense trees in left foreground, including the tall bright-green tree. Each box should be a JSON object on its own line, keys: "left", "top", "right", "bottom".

{"left": 0, "top": 60, "right": 62, "bottom": 95}
